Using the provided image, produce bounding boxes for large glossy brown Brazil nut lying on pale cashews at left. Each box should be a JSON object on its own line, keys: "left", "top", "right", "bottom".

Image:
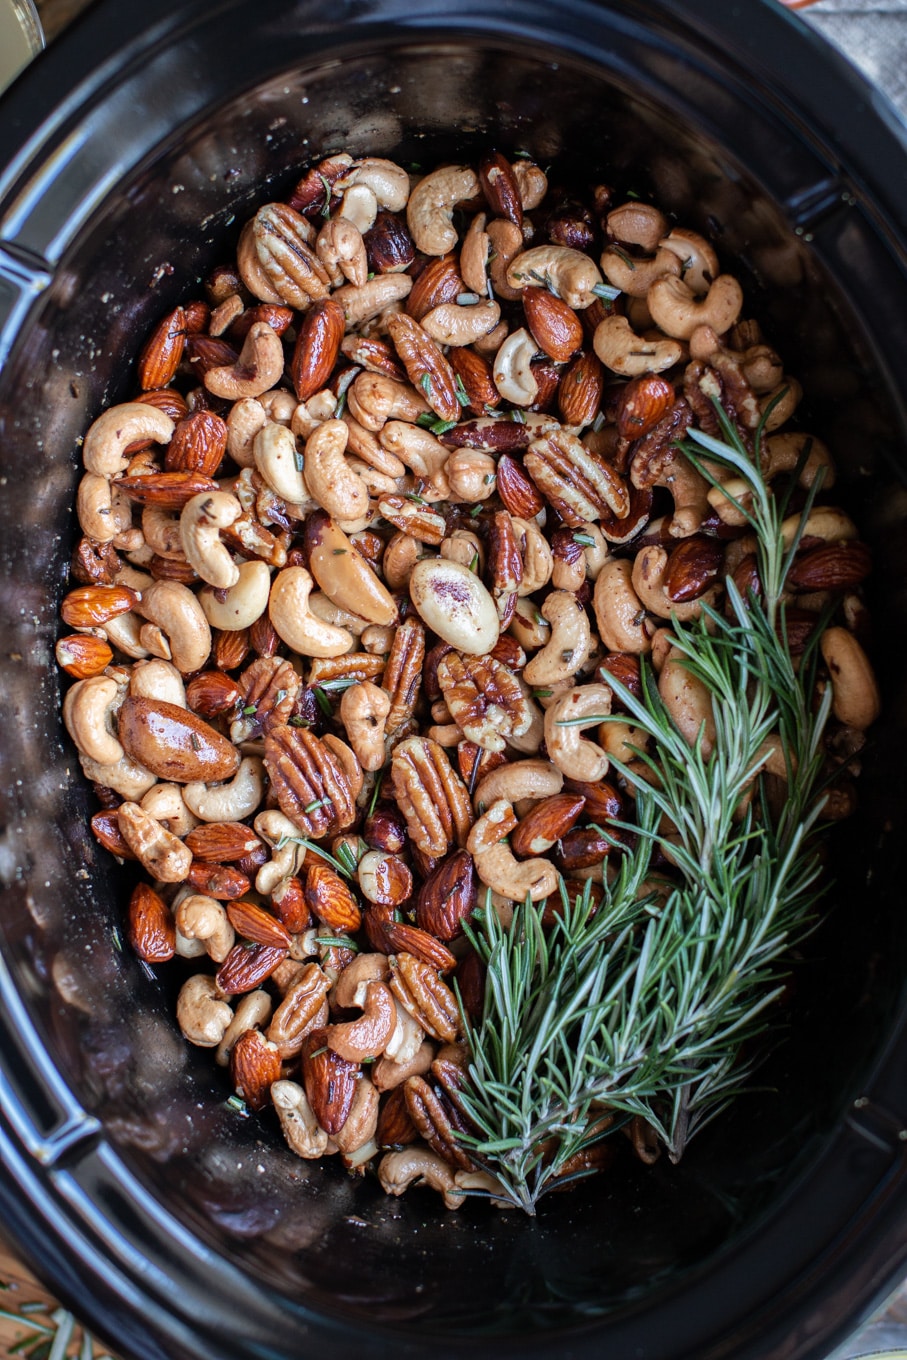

{"left": 118, "top": 695, "right": 239, "bottom": 783}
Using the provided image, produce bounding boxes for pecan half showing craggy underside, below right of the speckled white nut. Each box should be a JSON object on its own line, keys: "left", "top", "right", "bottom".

{"left": 438, "top": 651, "right": 532, "bottom": 751}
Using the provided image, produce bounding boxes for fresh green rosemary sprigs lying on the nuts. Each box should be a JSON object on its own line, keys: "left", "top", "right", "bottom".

{"left": 461, "top": 409, "right": 831, "bottom": 1213}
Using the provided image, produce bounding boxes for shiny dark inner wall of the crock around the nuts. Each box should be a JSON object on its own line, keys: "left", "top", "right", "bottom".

{"left": 1, "top": 18, "right": 907, "bottom": 1337}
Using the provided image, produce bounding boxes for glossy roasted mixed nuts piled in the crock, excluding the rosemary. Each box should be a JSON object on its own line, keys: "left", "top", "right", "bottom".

{"left": 57, "top": 152, "right": 878, "bottom": 1206}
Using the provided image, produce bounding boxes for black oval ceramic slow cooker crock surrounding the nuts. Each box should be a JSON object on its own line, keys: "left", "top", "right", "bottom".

{"left": 0, "top": 0, "right": 907, "bottom": 1360}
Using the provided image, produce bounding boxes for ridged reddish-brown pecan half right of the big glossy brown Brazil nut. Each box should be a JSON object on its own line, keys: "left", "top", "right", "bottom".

{"left": 265, "top": 724, "right": 356, "bottom": 840}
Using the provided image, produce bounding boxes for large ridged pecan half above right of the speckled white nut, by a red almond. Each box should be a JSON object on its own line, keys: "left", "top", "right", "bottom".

{"left": 525, "top": 430, "right": 630, "bottom": 529}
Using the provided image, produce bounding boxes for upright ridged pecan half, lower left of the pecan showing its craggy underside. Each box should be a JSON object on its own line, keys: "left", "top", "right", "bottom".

{"left": 390, "top": 737, "right": 472, "bottom": 855}
